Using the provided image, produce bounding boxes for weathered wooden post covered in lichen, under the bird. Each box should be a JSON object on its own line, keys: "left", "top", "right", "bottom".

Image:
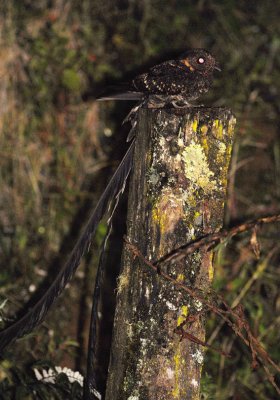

{"left": 106, "top": 107, "right": 235, "bottom": 400}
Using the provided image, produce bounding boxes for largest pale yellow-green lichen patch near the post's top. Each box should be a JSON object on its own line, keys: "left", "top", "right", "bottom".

{"left": 182, "top": 141, "right": 217, "bottom": 194}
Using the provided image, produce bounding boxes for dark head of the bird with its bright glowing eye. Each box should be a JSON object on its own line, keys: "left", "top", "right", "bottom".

{"left": 179, "top": 49, "right": 221, "bottom": 75}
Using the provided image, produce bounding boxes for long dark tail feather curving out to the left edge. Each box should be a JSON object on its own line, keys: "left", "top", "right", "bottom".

{"left": 0, "top": 140, "right": 135, "bottom": 353}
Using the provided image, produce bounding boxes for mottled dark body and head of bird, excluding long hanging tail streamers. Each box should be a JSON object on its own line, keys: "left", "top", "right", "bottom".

{"left": 98, "top": 49, "right": 220, "bottom": 107}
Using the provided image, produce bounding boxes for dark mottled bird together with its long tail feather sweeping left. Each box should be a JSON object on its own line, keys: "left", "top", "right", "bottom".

{"left": 0, "top": 49, "right": 219, "bottom": 354}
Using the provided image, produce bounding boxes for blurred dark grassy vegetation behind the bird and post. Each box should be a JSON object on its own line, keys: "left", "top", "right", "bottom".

{"left": 0, "top": 0, "right": 280, "bottom": 400}
